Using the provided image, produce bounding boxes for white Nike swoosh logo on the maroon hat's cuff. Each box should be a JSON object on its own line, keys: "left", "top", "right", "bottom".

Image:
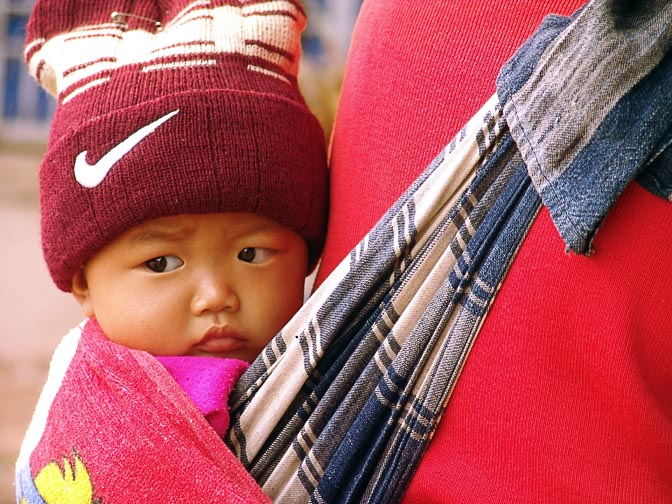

{"left": 75, "top": 109, "right": 180, "bottom": 189}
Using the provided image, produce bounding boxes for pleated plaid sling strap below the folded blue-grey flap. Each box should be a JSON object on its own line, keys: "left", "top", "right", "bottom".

{"left": 228, "top": 92, "right": 524, "bottom": 502}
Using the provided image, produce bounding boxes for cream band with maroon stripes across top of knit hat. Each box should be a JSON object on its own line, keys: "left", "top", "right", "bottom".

{"left": 25, "top": 0, "right": 306, "bottom": 103}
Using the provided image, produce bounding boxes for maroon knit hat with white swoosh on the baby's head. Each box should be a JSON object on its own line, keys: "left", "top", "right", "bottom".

{"left": 25, "top": 0, "right": 327, "bottom": 291}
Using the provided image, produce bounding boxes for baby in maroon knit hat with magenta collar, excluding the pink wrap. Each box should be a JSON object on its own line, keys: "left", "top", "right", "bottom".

{"left": 26, "top": 0, "right": 327, "bottom": 434}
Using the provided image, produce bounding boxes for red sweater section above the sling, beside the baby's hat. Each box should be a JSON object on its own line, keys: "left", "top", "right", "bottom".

{"left": 317, "top": 0, "right": 584, "bottom": 284}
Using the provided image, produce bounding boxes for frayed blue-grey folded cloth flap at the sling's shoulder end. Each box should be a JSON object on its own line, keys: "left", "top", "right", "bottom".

{"left": 497, "top": 0, "right": 672, "bottom": 254}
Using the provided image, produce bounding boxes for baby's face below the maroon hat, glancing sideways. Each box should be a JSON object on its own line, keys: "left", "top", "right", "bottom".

{"left": 73, "top": 213, "right": 308, "bottom": 361}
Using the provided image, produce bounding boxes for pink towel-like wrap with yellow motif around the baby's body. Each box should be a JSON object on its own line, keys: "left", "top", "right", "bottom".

{"left": 16, "top": 320, "right": 270, "bottom": 504}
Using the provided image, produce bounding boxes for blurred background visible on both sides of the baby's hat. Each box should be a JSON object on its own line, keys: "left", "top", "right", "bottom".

{"left": 0, "top": 0, "right": 362, "bottom": 504}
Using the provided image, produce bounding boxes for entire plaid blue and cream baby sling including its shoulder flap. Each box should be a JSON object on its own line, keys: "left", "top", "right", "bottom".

{"left": 227, "top": 1, "right": 672, "bottom": 502}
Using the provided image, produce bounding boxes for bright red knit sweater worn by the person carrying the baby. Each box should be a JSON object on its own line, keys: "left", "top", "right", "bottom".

{"left": 318, "top": 0, "right": 672, "bottom": 503}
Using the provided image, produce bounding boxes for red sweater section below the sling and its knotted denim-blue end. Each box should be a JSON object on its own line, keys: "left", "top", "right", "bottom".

{"left": 406, "top": 184, "right": 672, "bottom": 503}
